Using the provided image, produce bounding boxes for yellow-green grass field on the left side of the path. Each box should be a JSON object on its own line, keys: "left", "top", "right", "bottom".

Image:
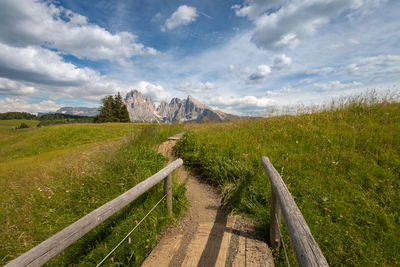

{"left": 0, "top": 120, "right": 186, "bottom": 266}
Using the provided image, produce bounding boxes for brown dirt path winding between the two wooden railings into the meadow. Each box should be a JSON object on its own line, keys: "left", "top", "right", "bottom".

{"left": 142, "top": 137, "right": 274, "bottom": 267}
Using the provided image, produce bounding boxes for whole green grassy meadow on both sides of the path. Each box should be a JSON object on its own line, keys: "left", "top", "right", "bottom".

{"left": 0, "top": 93, "right": 400, "bottom": 266}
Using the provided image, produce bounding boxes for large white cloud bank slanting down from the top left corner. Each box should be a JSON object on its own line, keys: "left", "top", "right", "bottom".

{"left": 0, "top": 0, "right": 157, "bottom": 63}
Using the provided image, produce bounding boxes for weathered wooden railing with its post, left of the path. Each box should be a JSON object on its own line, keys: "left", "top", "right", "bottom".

{"left": 5, "top": 159, "right": 183, "bottom": 267}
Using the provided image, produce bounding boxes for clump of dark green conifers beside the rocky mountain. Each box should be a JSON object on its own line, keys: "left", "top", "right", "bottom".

{"left": 94, "top": 92, "right": 130, "bottom": 122}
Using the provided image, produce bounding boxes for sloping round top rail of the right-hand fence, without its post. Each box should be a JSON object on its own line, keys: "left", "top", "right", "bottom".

{"left": 261, "top": 157, "right": 329, "bottom": 266}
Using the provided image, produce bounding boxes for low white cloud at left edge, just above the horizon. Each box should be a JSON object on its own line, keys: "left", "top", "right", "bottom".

{"left": 0, "top": 97, "right": 61, "bottom": 113}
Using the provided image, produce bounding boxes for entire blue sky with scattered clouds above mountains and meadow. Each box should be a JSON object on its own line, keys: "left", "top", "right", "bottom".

{"left": 0, "top": 0, "right": 400, "bottom": 116}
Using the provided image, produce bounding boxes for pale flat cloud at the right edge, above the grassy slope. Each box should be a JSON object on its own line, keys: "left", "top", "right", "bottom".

{"left": 347, "top": 55, "right": 400, "bottom": 80}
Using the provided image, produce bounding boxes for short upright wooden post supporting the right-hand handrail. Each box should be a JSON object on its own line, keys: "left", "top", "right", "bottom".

{"left": 269, "top": 186, "right": 281, "bottom": 250}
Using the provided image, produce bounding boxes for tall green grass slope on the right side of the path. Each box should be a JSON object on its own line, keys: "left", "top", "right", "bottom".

{"left": 175, "top": 97, "right": 400, "bottom": 266}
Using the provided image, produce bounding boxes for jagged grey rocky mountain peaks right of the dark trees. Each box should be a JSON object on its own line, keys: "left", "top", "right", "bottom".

{"left": 125, "top": 90, "right": 232, "bottom": 122}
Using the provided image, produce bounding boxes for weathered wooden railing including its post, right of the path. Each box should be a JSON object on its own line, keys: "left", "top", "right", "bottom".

{"left": 261, "top": 157, "right": 329, "bottom": 266}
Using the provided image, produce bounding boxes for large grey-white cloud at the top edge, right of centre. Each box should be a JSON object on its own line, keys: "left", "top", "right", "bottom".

{"left": 238, "top": 0, "right": 371, "bottom": 50}
